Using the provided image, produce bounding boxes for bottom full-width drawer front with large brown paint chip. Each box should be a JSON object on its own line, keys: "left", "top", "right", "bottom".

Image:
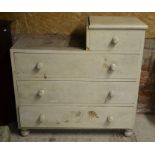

{"left": 19, "top": 105, "right": 134, "bottom": 129}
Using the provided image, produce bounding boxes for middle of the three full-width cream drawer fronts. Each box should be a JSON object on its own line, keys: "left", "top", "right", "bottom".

{"left": 17, "top": 81, "right": 137, "bottom": 106}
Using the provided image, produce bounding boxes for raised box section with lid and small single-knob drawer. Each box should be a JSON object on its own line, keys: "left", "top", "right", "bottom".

{"left": 86, "top": 16, "right": 147, "bottom": 53}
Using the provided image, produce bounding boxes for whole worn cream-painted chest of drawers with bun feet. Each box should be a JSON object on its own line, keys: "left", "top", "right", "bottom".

{"left": 11, "top": 16, "right": 147, "bottom": 136}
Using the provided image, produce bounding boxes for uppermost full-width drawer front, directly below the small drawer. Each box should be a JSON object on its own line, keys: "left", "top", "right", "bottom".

{"left": 14, "top": 53, "right": 139, "bottom": 79}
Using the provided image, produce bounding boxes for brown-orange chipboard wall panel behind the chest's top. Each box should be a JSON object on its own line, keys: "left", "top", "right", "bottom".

{"left": 0, "top": 12, "right": 155, "bottom": 38}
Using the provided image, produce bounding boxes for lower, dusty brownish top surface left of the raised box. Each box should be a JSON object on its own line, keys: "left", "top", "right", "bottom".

{"left": 11, "top": 34, "right": 84, "bottom": 51}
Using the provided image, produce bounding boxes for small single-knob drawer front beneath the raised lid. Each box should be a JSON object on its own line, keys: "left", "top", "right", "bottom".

{"left": 87, "top": 30, "right": 144, "bottom": 53}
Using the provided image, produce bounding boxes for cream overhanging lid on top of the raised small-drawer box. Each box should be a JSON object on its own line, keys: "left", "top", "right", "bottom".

{"left": 88, "top": 16, "right": 148, "bottom": 30}
